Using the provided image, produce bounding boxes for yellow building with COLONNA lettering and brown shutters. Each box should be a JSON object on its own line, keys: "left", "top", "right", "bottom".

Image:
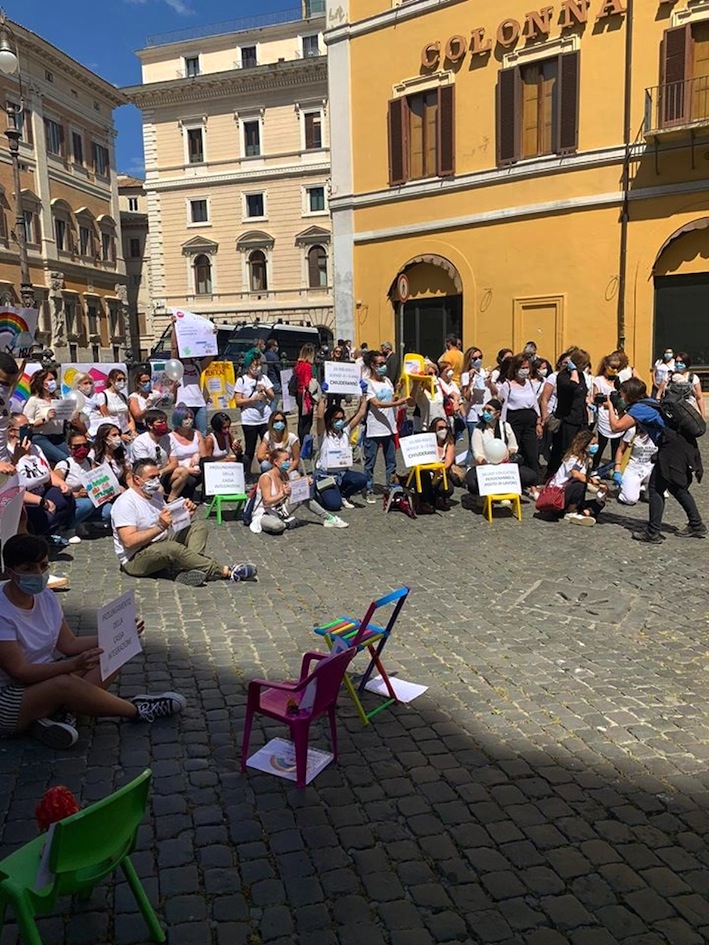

{"left": 325, "top": 0, "right": 709, "bottom": 375}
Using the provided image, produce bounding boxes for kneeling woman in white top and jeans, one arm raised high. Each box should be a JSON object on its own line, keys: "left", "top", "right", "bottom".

{"left": 315, "top": 381, "right": 367, "bottom": 512}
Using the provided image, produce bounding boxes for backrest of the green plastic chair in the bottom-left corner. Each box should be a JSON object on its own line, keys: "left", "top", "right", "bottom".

{"left": 49, "top": 769, "right": 152, "bottom": 895}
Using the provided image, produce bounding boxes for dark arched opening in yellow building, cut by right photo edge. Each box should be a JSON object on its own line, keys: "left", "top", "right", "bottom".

{"left": 653, "top": 217, "right": 709, "bottom": 370}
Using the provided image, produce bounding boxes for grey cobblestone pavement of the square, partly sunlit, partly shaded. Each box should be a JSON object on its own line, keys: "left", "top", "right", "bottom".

{"left": 0, "top": 466, "right": 709, "bottom": 945}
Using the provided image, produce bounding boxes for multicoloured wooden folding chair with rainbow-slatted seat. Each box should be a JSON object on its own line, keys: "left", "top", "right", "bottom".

{"left": 314, "top": 587, "right": 411, "bottom": 725}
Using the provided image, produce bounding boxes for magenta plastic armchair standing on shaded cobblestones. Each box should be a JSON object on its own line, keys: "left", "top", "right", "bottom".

{"left": 241, "top": 649, "right": 356, "bottom": 787}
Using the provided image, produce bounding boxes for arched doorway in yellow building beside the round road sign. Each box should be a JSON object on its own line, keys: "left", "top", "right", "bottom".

{"left": 389, "top": 254, "right": 463, "bottom": 361}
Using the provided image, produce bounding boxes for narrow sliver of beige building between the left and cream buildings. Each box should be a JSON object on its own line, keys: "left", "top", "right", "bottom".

{"left": 118, "top": 174, "right": 153, "bottom": 359}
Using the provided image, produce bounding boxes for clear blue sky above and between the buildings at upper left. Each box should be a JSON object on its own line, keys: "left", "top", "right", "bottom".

{"left": 4, "top": 0, "right": 300, "bottom": 177}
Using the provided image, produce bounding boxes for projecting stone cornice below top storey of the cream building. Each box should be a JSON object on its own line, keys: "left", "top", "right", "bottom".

{"left": 121, "top": 56, "right": 327, "bottom": 108}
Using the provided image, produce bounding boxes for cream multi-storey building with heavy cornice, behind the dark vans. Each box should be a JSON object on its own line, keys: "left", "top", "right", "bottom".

{"left": 125, "top": 4, "right": 332, "bottom": 344}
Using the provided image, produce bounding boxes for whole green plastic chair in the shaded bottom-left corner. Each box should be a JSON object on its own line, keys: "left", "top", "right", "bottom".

{"left": 0, "top": 770, "right": 165, "bottom": 945}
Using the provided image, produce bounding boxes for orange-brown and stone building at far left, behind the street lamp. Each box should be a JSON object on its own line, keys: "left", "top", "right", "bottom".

{"left": 0, "top": 21, "right": 128, "bottom": 361}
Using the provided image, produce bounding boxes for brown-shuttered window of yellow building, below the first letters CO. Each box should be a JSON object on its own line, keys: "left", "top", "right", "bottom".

{"left": 389, "top": 85, "right": 455, "bottom": 185}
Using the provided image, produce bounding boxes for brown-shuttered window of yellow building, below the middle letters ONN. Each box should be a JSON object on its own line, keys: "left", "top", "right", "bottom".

{"left": 497, "top": 52, "right": 580, "bottom": 165}
